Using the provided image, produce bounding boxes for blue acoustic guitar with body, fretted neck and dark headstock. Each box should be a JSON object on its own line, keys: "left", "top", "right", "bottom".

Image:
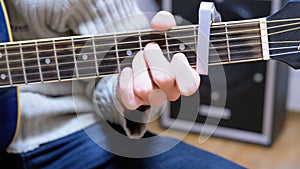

{"left": 0, "top": 0, "right": 300, "bottom": 151}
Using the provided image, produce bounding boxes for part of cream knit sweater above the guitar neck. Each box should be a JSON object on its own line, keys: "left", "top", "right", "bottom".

{"left": 6, "top": 0, "right": 149, "bottom": 40}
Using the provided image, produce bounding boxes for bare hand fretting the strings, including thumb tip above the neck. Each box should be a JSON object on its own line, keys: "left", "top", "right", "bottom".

{"left": 117, "top": 11, "right": 200, "bottom": 110}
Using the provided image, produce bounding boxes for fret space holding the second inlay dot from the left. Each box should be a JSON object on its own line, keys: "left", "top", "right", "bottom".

{"left": 36, "top": 40, "right": 59, "bottom": 82}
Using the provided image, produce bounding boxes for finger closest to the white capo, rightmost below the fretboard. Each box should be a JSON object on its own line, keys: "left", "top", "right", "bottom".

{"left": 171, "top": 53, "right": 200, "bottom": 96}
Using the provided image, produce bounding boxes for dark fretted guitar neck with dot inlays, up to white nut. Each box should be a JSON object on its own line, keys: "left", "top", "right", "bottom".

{"left": 0, "top": 19, "right": 268, "bottom": 87}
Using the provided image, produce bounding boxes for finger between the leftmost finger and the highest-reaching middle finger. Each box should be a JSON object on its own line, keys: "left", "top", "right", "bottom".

{"left": 132, "top": 51, "right": 153, "bottom": 103}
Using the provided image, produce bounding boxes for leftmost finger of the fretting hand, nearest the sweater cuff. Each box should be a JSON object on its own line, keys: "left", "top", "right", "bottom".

{"left": 118, "top": 67, "right": 143, "bottom": 110}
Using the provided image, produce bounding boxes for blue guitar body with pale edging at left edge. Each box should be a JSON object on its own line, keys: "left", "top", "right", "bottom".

{"left": 0, "top": 0, "right": 20, "bottom": 151}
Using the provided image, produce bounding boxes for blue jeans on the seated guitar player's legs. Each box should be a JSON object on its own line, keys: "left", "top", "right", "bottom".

{"left": 0, "top": 125, "right": 244, "bottom": 169}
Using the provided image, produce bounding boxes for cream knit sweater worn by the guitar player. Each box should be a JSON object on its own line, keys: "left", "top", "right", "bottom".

{"left": 6, "top": 0, "right": 157, "bottom": 153}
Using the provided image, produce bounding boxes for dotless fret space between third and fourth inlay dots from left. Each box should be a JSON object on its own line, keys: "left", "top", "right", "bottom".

{"left": 95, "top": 35, "right": 121, "bottom": 76}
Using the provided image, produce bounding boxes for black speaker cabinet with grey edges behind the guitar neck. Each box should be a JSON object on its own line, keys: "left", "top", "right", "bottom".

{"left": 160, "top": 0, "right": 289, "bottom": 146}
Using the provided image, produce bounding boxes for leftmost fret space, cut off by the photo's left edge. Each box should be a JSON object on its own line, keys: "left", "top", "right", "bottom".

{"left": 0, "top": 44, "right": 12, "bottom": 86}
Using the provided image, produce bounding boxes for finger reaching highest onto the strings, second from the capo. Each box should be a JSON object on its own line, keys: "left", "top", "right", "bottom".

{"left": 144, "top": 43, "right": 180, "bottom": 101}
